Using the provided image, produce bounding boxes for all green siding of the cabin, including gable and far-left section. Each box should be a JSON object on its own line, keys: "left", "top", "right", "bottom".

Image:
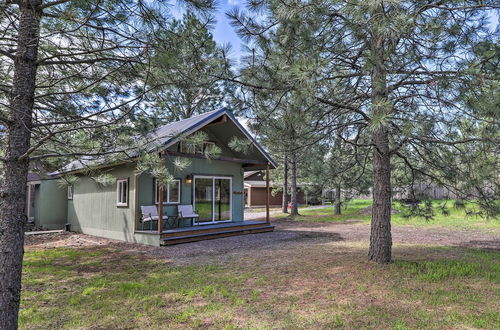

{"left": 31, "top": 118, "right": 265, "bottom": 245}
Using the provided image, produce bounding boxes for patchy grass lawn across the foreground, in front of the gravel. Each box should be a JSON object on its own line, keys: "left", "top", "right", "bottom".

{"left": 19, "top": 241, "right": 500, "bottom": 329}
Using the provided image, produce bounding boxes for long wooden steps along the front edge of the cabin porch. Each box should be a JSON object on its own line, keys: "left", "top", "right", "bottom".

{"left": 160, "top": 222, "right": 274, "bottom": 245}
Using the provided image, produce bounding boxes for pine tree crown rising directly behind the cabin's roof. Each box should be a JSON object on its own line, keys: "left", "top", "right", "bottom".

{"left": 143, "top": 12, "right": 233, "bottom": 122}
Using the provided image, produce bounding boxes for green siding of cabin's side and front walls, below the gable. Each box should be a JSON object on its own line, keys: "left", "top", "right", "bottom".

{"left": 67, "top": 158, "right": 243, "bottom": 245}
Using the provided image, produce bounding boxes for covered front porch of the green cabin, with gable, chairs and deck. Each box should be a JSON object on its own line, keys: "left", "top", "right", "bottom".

{"left": 132, "top": 111, "right": 276, "bottom": 245}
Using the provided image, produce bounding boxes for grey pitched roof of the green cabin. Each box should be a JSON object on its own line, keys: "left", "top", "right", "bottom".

{"left": 50, "top": 108, "right": 278, "bottom": 175}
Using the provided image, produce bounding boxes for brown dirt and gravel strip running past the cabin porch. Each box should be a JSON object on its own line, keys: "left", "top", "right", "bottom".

{"left": 25, "top": 220, "right": 500, "bottom": 264}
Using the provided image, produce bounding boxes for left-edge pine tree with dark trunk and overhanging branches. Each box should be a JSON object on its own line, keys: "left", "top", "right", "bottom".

{"left": 0, "top": 0, "right": 213, "bottom": 329}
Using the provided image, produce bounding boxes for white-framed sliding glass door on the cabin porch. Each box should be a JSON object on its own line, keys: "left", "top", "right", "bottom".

{"left": 193, "top": 176, "right": 232, "bottom": 224}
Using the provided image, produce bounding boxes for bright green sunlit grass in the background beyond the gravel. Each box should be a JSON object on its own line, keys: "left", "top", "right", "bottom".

{"left": 280, "top": 199, "right": 500, "bottom": 230}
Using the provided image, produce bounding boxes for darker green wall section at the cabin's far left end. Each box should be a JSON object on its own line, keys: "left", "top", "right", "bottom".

{"left": 34, "top": 180, "right": 67, "bottom": 229}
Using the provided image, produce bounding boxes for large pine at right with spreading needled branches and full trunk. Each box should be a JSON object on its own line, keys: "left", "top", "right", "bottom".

{"left": 229, "top": 0, "right": 499, "bottom": 263}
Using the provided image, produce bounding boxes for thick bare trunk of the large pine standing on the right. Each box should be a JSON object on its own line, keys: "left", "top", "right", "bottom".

{"left": 368, "top": 24, "right": 392, "bottom": 263}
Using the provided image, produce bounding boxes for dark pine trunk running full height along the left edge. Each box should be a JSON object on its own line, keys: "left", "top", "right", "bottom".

{"left": 0, "top": 0, "right": 42, "bottom": 329}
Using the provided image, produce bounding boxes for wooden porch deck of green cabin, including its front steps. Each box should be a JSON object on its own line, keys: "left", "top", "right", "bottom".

{"left": 136, "top": 221, "right": 274, "bottom": 245}
